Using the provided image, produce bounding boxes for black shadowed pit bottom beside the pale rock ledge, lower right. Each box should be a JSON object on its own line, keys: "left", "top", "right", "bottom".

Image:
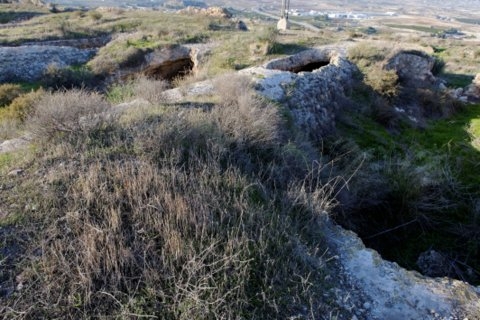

{"left": 335, "top": 200, "right": 480, "bottom": 285}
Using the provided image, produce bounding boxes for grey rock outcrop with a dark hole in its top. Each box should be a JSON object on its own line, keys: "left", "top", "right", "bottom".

{"left": 241, "top": 48, "right": 358, "bottom": 140}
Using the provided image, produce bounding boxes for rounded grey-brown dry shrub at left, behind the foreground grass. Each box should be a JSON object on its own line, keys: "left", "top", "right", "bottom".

{"left": 28, "top": 90, "right": 109, "bottom": 140}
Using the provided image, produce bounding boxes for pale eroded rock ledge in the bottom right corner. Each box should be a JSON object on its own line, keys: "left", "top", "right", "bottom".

{"left": 322, "top": 221, "right": 480, "bottom": 320}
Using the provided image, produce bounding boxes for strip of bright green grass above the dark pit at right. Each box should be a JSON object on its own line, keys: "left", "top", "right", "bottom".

{"left": 347, "top": 104, "right": 480, "bottom": 187}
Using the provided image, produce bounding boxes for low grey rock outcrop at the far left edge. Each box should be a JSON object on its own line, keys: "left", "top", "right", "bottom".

{"left": 0, "top": 45, "right": 96, "bottom": 82}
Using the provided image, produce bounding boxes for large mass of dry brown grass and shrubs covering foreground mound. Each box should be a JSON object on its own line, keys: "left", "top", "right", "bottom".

{"left": 0, "top": 79, "right": 342, "bottom": 319}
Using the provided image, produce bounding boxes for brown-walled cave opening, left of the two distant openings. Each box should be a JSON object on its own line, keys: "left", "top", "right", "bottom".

{"left": 144, "top": 58, "right": 195, "bottom": 81}
